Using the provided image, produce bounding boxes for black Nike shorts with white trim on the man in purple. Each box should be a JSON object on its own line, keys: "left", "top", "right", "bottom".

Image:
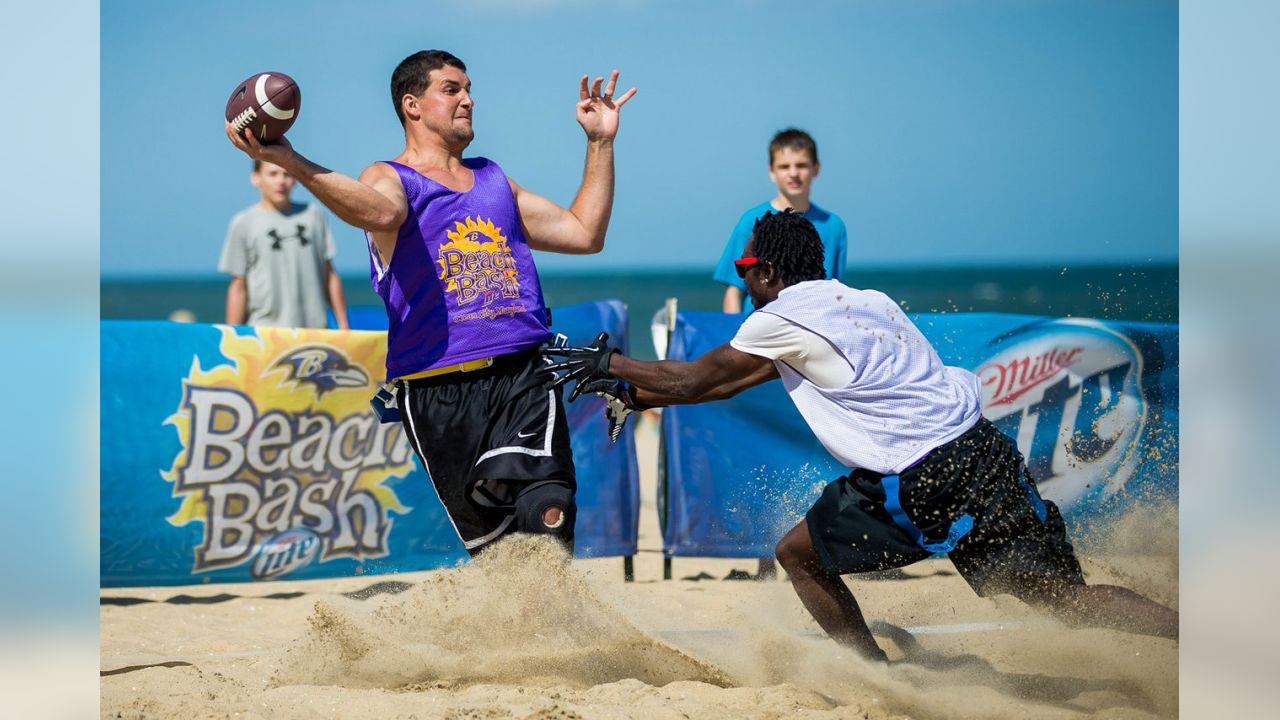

{"left": 397, "top": 348, "right": 577, "bottom": 552}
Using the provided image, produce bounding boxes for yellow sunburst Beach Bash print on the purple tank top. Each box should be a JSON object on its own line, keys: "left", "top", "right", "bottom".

{"left": 436, "top": 210, "right": 525, "bottom": 316}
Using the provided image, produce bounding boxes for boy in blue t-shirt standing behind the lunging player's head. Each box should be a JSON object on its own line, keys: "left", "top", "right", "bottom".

{"left": 713, "top": 128, "right": 849, "bottom": 313}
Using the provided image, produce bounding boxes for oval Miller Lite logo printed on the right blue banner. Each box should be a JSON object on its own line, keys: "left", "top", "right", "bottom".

{"left": 975, "top": 320, "right": 1147, "bottom": 510}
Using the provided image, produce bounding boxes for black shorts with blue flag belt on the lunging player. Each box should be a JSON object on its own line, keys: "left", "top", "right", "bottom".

{"left": 805, "top": 418, "right": 1084, "bottom": 600}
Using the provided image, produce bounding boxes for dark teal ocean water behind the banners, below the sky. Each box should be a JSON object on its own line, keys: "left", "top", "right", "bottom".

{"left": 101, "top": 263, "right": 1178, "bottom": 359}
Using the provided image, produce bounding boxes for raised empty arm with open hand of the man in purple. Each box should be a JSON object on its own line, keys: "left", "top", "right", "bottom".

{"left": 508, "top": 70, "right": 636, "bottom": 254}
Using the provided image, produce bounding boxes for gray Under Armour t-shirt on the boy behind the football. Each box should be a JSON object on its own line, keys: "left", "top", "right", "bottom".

{"left": 218, "top": 204, "right": 337, "bottom": 328}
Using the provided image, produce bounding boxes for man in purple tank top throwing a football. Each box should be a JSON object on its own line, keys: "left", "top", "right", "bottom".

{"left": 227, "top": 50, "right": 636, "bottom": 555}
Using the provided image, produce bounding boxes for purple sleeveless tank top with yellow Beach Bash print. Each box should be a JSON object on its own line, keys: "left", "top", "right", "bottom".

{"left": 369, "top": 158, "right": 550, "bottom": 378}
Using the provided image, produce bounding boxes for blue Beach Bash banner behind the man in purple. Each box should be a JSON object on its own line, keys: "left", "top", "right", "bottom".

{"left": 100, "top": 301, "right": 640, "bottom": 587}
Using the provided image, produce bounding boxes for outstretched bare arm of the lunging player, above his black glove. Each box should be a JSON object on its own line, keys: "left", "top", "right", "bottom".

{"left": 609, "top": 342, "right": 778, "bottom": 405}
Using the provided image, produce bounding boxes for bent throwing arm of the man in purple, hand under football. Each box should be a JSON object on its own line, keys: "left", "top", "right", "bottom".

{"left": 227, "top": 123, "right": 408, "bottom": 263}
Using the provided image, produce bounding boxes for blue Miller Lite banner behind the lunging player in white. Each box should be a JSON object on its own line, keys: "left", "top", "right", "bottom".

{"left": 659, "top": 313, "right": 1178, "bottom": 557}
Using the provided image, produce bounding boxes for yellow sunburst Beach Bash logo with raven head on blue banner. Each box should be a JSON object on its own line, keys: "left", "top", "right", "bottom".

{"left": 161, "top": 327, "right": 413, "bottom": 579}
